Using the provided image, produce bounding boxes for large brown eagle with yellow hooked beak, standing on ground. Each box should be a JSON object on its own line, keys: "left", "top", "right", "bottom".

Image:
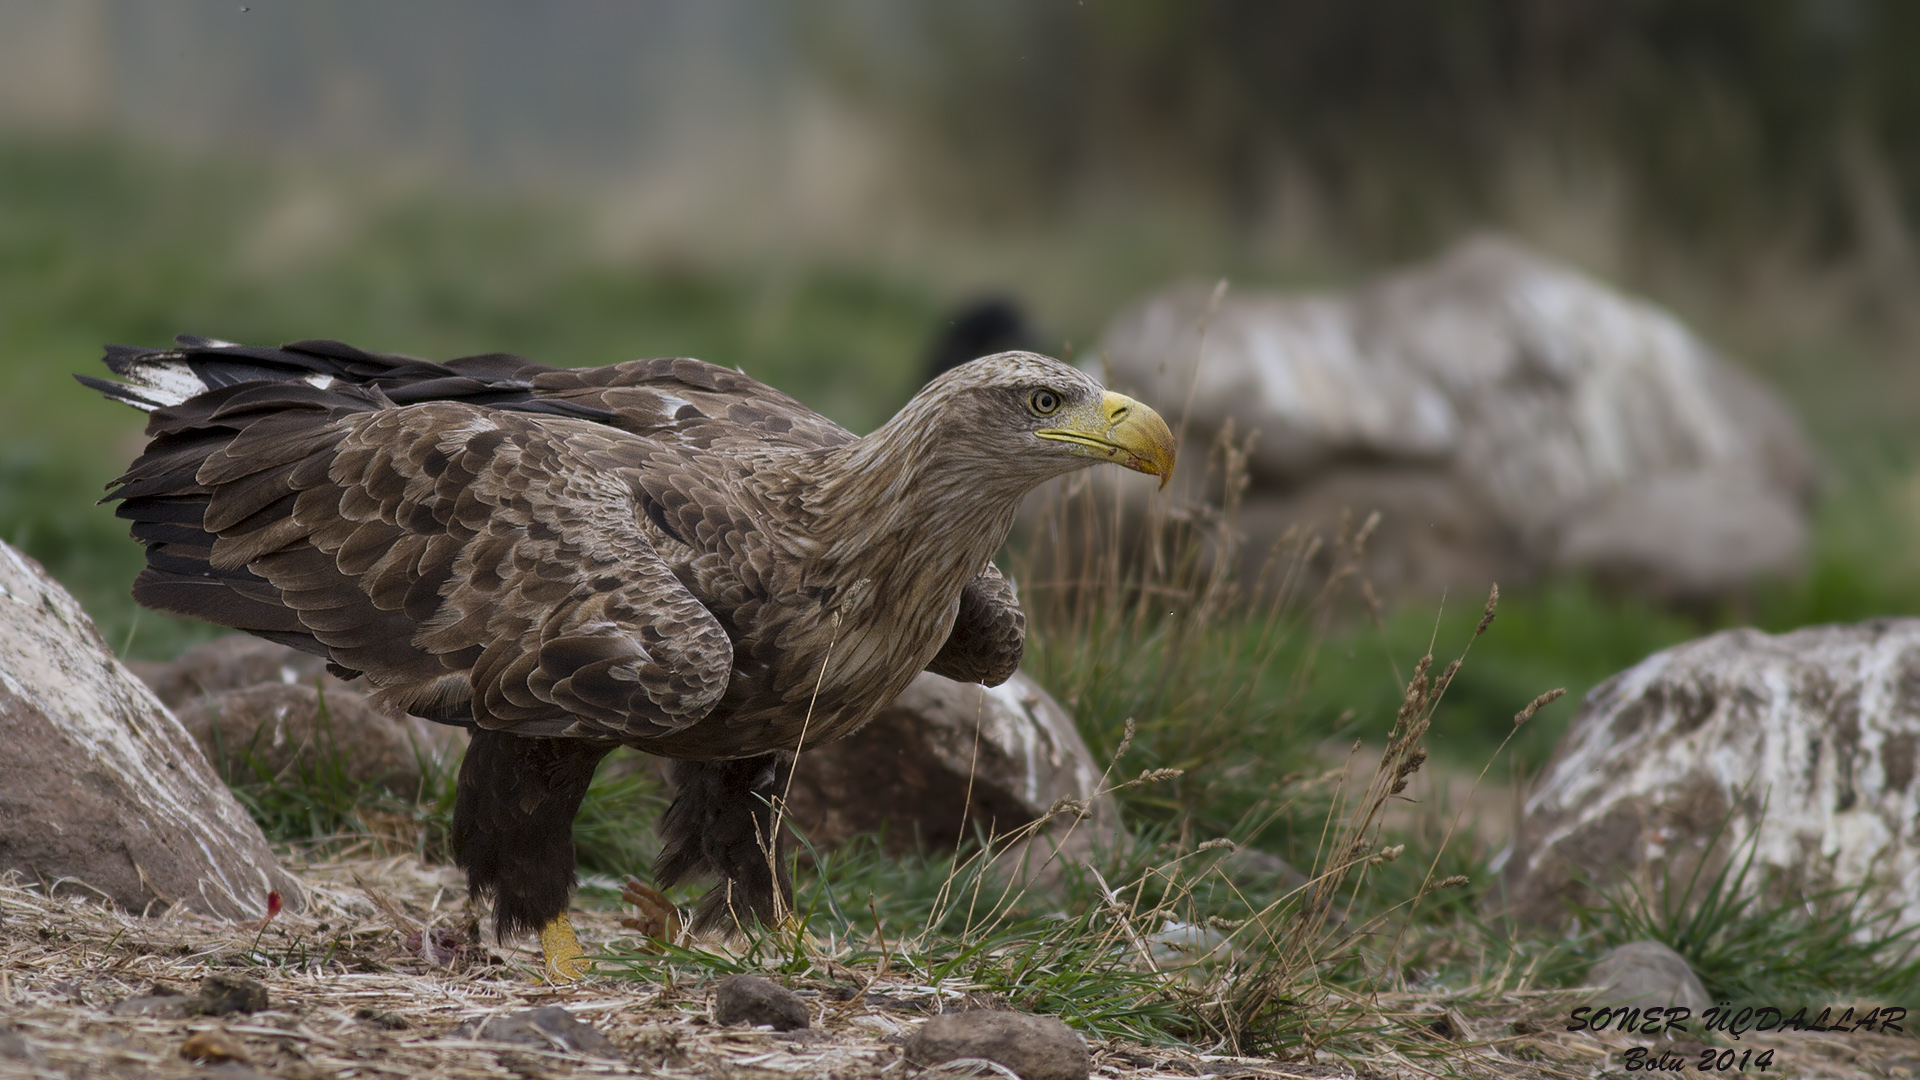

{"left": 81, "top": 336, "right": 1173, "bottom": 978}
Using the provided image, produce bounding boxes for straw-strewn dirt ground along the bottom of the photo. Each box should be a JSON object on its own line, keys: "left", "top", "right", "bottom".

{"left": 0, "top": 857, "right": 1920, "bottom": 1080}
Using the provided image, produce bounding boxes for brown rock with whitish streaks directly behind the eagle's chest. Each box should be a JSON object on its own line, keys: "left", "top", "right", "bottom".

{"left": 787, "top": 673, "right": 1117, "bottom": 851}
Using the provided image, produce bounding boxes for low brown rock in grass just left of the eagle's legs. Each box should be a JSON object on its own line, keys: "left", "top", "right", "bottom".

{"left": 177, "top": 682, "right": 426, "bottom": 798}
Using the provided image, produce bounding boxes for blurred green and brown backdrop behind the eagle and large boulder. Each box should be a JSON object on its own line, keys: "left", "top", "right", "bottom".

{"left": 0, "top": 0, "right": 1920, "bottom": 771}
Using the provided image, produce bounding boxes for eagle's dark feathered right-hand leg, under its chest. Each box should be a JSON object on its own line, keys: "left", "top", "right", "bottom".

{"left": 653, "top": 753, "right": 793, "bottom": 930}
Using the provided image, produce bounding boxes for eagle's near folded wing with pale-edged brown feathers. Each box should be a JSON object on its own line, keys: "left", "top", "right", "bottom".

{"left": 115, "top": 382, "right": 733, "bottom": 738}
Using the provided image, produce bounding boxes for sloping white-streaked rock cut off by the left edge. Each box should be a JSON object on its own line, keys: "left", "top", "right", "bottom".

{"left": 0, "top": 544, "right": 305, "bottom": 919}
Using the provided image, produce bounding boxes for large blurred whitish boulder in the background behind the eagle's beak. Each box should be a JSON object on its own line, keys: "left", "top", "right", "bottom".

{"left": 1085, "top": 238, "right": 1814, "bottom": 600}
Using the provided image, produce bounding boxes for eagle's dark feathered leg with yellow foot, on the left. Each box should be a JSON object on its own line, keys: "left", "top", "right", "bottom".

{"left": 453, "top": 730, "right": 616, "bottom": 980}
